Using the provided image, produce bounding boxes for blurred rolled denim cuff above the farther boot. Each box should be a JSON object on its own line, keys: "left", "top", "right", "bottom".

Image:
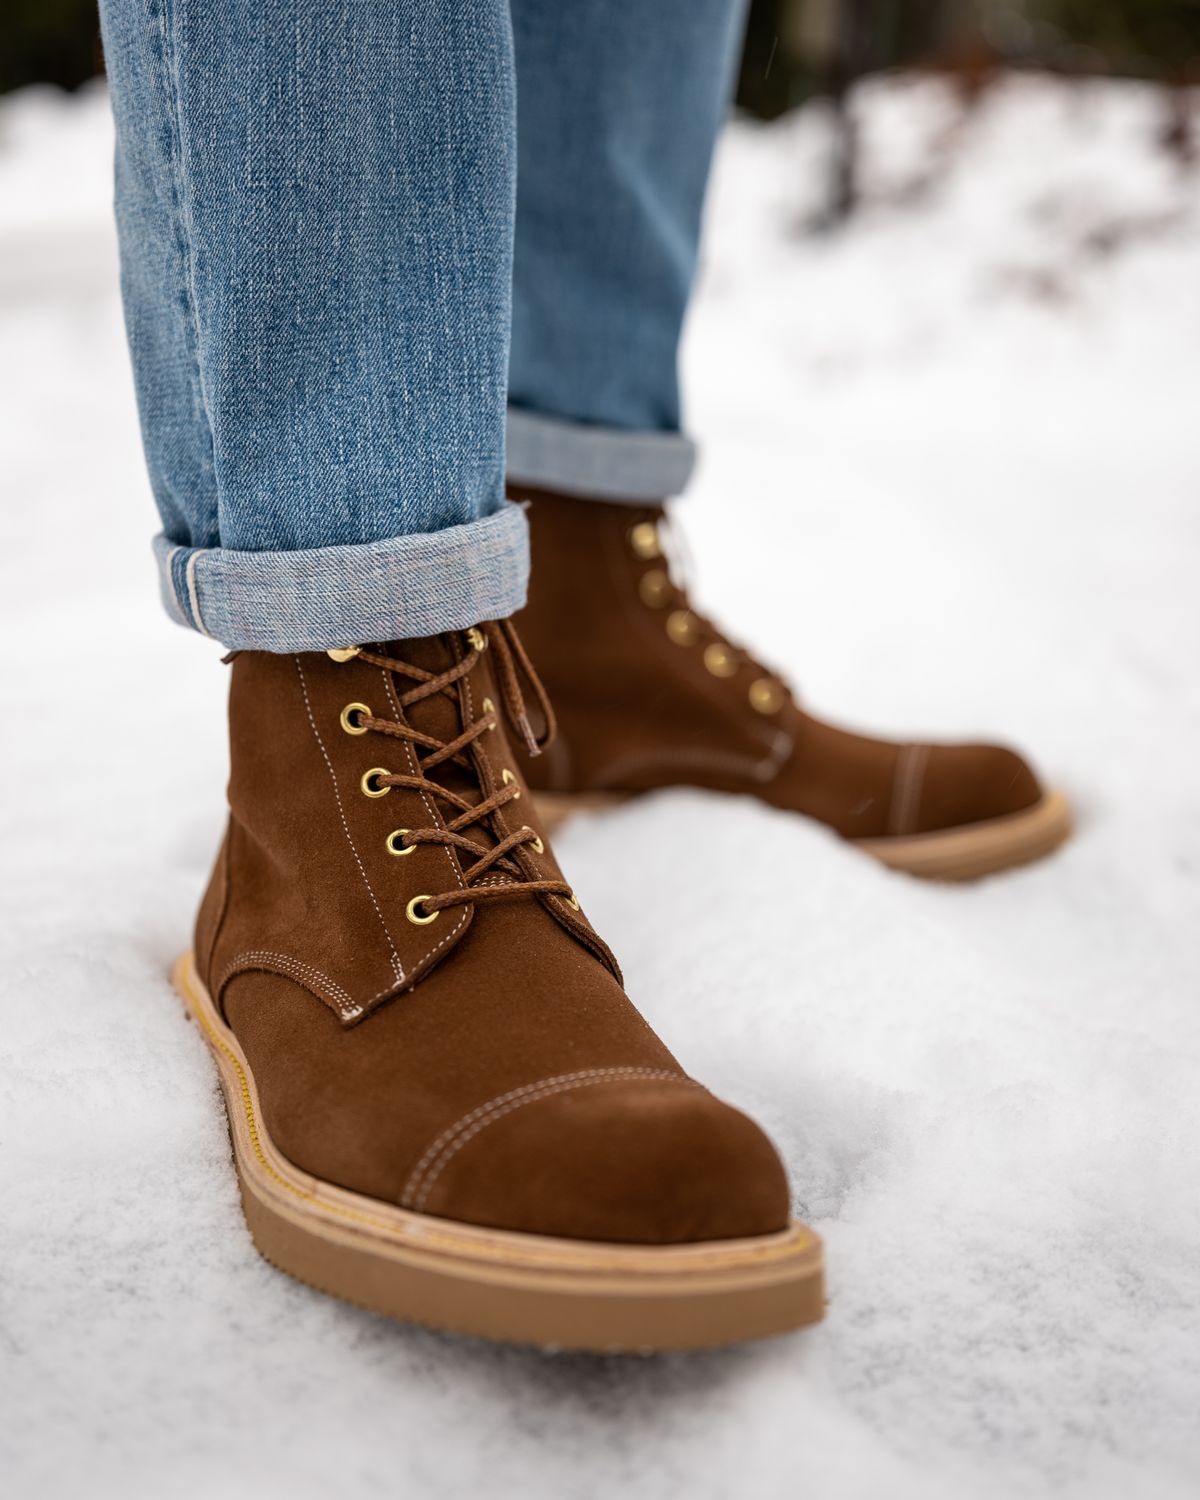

{"left": 507, "top": 407, "right": 696, "bottom": 504}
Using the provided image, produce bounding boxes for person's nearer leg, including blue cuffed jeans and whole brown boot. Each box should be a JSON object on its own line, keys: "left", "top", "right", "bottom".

{"left": 104, "top": 0, "right": 822, "bottom": 1349}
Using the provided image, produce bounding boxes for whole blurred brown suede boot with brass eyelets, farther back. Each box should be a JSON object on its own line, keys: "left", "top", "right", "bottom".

{"left": 512, "top": 488, "right": 1070, "bottom": 879}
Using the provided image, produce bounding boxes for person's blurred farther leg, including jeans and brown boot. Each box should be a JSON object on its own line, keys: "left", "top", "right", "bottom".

{"left": 509, "top": 0, "right": 1070, "bottom": 876}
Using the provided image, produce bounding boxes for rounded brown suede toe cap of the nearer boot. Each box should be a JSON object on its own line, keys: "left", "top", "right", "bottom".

{"left": 405, "top": 1070, "right": 789, "bottom": 1245}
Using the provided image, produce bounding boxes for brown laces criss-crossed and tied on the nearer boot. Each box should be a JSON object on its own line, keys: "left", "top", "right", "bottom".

{"left": 346, "top": 620, "right": 575, "bottom": 918}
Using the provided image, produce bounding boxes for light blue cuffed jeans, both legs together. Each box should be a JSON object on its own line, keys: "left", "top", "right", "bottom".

{"left": 101, "top": 0, "right": 743, "bottom": 651}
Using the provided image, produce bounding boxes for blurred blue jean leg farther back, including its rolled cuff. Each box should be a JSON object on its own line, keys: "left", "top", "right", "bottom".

{"left": 509, "top": 0, "right": 746, "bottom": 500}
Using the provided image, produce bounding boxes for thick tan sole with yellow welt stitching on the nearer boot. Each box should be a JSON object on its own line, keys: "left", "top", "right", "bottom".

{"left": 171, "top": 954, "right": 825, "bottom": 1353}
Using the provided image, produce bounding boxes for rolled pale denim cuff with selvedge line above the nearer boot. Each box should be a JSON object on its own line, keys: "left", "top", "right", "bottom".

{"left": 155, "top": 504, "right": 530, "bottom": 651}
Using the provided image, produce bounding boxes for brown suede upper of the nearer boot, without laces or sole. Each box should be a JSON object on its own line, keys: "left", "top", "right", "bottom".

{"left": 195, "top": 635, "right": 789, "bottom": 1245}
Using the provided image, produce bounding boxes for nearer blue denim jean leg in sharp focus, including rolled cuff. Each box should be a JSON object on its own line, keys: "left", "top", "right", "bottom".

{"left": 101, "top": 0, "right": 528, "bottom": 650}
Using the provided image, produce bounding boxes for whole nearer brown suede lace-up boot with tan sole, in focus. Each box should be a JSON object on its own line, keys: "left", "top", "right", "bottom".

{"left": 176, "top": 623, "right": 824, "bottom": 1350}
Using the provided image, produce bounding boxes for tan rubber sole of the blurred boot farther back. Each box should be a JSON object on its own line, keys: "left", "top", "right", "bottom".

{"left": 534, "top": 792, "right": 1071, "bottom": 881}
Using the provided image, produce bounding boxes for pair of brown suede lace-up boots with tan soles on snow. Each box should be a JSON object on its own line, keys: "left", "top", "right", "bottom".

{"left": 176, "top": 494, "right": 1068, "bottom": 1350}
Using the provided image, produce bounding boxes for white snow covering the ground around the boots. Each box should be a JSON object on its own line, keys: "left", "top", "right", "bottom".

{"left": 0, "top": 80, "right": 1200, "bottom": 1500}
